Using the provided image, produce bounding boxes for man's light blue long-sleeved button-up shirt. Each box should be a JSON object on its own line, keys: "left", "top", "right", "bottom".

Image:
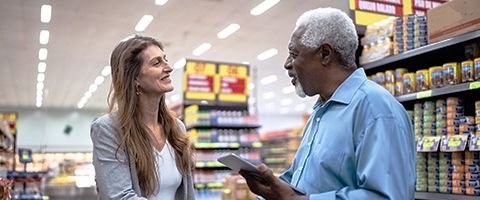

{"left": 281, "top": 68, "right": 416, "bottom": 200}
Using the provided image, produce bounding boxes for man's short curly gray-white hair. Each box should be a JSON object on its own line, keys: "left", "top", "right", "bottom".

{"left": 295, "top": 8, "right": 358, "bottom": 68}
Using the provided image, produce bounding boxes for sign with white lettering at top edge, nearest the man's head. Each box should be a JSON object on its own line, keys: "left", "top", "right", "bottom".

{"left": 355, "top": 0, "right": 403, "bottom": 16}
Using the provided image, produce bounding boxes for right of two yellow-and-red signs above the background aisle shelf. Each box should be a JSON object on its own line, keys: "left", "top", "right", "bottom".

{"left": 217, "top": 64, "right": 248, "bottom": 102}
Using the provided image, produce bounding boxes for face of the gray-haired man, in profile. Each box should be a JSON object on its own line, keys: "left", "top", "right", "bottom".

{"left": 284, "top": 27, "right": 320, "bottom": 97}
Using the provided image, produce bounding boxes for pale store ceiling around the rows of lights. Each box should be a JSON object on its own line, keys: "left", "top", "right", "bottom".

{"left": 0, "top": 0, "right": 348, "bottom": 113}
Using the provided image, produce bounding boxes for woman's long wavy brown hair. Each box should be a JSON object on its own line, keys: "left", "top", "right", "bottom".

{"left": 108, "top": 35, "right": 193, "bottom": 196}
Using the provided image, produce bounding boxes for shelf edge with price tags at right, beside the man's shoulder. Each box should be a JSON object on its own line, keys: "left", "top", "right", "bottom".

{"left": 395, "top": 81, "right": 480, "bottom": 102}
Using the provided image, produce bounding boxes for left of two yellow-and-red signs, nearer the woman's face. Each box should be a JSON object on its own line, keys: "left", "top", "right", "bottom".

{"left": 183, "top": 61, "right": 216, "bottom": 101}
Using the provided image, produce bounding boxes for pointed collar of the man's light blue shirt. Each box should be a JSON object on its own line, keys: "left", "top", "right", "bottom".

{"left": 313, "top": 68, "right": 367, "bottom": 109}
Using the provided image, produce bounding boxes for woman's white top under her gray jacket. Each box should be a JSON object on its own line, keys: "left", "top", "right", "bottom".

{"left": 148, "top": 141, "right": 182, "bottom": 200}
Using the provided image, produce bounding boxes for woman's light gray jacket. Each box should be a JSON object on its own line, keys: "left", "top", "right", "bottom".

{"left": 90, "top": 114, "right": 195, "bottom": 200}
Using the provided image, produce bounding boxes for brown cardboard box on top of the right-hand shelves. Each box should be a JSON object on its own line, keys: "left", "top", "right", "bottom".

{"left": 427, "top": 0, "right": 480, "bottom": 43}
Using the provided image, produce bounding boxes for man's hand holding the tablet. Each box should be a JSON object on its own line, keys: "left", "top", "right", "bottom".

{"left": 240, "top": 164, "right": 308, "bottom": 200}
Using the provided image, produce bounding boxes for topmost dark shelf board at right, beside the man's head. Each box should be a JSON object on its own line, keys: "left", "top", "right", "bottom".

{"left": 362, "top": 30, "right": 480, "bottom": 70}
